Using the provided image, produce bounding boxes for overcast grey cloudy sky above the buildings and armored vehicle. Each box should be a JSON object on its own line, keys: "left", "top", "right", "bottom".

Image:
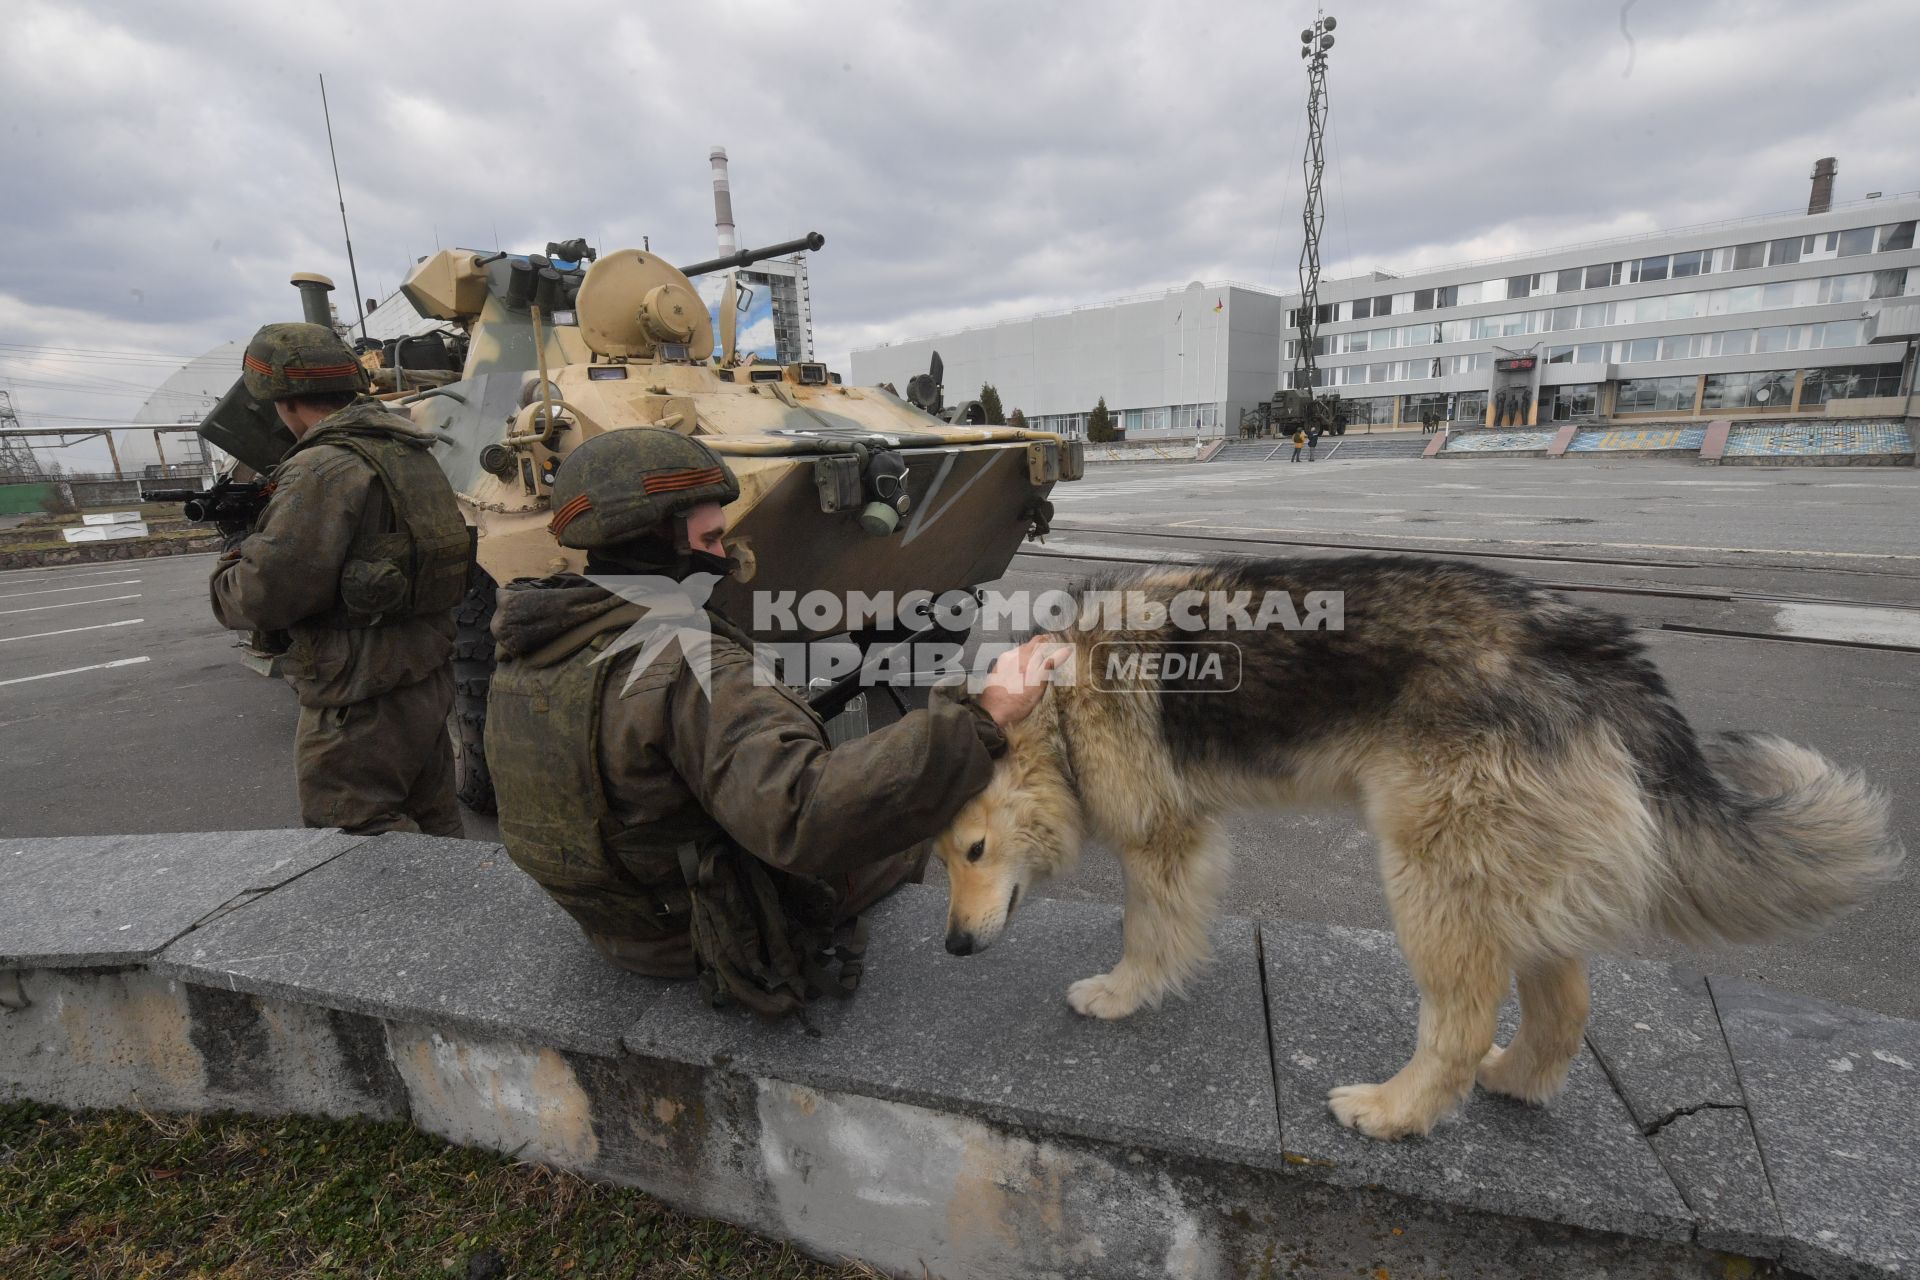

{"left": 0, "top": 0, "right": 1920, "bottom": 441}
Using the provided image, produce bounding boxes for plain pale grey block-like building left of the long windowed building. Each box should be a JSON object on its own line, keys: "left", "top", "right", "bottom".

{"left": 852, "top": 282, "right": 1283, "bottom": 439}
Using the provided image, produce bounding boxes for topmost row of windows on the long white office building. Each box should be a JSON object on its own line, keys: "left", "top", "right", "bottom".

{"left": 1286, "top": 221, "right": 1914, "bottom": 328}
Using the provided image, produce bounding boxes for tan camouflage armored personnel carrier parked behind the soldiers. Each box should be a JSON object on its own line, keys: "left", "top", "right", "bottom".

{"left": 200, "top": 234, "right": 1083, "bottom": 810}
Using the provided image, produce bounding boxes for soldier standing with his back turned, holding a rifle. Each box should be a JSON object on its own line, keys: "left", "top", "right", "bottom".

{"left": 211, "top": 324, "right": 472, "bottom": 835}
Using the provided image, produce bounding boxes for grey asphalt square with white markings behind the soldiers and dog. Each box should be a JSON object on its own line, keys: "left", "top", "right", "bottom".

{"left": 0, "top": 459, "right": 1920, "bottom": 1017}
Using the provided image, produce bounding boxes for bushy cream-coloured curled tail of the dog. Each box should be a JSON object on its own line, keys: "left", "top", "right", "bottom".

{"left": 1659, "top": 733, "right": 1907, "bottom": 942}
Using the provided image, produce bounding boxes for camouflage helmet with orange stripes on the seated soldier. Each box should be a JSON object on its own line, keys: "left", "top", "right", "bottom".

{"left": 547, "top": 426, "right": 739, "bottom": 551}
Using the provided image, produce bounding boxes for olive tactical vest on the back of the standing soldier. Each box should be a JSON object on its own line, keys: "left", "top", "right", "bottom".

{"left": 301, "top": 411, "right": 472, "bottom": 631}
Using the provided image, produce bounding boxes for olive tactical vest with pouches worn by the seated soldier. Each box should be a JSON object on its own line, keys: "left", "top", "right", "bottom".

{"left": 486, "top": 610, "right": 866, "bottom": 1015}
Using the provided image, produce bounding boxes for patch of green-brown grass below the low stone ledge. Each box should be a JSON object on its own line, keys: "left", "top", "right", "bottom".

{"left": 0, "top": 1103, "right": 876, "bottom": 1280}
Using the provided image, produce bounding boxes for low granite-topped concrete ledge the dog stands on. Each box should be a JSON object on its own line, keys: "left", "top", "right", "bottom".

{"left": 0, "top": 831, "right": 1920, "bottom": 1280}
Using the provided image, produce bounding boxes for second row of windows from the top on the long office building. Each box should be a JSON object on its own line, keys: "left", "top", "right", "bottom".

{"left": 1284, "top": 267, "right": 1896, "bottom": 361}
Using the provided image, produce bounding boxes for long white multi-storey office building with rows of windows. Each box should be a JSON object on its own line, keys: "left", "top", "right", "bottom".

{"left": 1281, "top": 184, "right": 1920, "bottom": 426}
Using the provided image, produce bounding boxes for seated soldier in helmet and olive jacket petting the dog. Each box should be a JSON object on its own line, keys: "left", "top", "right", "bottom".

{"left": 486, "top": 428, "right": 1052, "bottom": 1013}
